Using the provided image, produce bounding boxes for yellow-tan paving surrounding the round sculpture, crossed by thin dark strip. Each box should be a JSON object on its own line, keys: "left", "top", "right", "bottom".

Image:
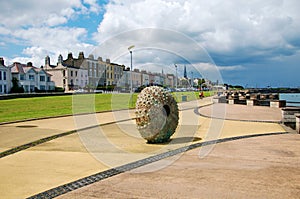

{"left": 0, "top": 99, "right": 292, "bottom": 198}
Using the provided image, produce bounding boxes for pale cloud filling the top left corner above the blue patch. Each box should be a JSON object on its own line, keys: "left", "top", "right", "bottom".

{"left": 0, "top": 0, "right": 101, "bottom": 29}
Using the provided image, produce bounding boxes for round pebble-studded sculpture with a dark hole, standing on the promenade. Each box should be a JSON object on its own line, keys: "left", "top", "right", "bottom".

{"left": 135, "top": 86, "right": 178, "bottom": 143}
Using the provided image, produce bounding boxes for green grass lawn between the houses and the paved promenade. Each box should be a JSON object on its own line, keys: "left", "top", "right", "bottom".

{"left": 0, "top": 92, "right": 211, "bottom": 122}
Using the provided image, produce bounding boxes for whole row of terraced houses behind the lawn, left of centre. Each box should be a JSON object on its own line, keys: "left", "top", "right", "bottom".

{"left": 0, "top": 52, "right": 176, "bottom": 94}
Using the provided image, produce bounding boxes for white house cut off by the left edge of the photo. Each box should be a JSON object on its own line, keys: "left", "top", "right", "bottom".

{"left": 0, "top": 57, "right": 11, "bottom": 94}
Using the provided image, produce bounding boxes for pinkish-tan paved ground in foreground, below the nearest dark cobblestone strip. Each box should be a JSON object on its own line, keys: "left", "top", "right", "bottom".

{"left": 59, "top": 134, "right": 300, "bottom": 199}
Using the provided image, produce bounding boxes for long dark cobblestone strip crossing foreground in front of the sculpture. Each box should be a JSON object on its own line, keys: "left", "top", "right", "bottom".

{"left": 28, "top": 132, "right": 287, "bottom": 199}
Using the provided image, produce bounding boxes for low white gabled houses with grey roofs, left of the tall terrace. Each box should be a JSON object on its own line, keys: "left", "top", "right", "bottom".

{"left": 10, "top": 62, "right": 55, "bottom": 93}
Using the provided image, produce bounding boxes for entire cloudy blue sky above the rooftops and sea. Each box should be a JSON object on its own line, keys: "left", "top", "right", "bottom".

{"left": 0, "top": 0, "right": 300, "bottom": 87}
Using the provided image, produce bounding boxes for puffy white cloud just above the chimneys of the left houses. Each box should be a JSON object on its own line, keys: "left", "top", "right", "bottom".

{"left": 3, "top": 27, "right": 93, "bottom": 66}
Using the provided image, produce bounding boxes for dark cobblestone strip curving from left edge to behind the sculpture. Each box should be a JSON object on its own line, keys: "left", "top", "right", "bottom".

{"left": 0, "top": 118, "right": 133, "bottom": 159}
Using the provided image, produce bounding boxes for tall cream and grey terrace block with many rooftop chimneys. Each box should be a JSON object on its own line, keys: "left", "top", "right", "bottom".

{"left": 45, "top": 52, "right": 123, "bottom": 91}
